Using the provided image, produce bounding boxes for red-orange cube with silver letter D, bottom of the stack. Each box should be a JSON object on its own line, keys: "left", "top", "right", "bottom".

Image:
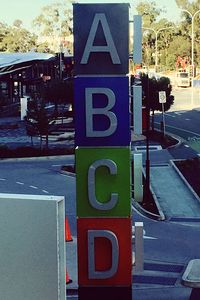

{"left": 77, "top": 218, "right": 132, "bottom": 286}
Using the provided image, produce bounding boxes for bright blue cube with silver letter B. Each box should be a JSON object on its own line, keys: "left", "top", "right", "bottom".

{"left": 74, "top": 76, "right": 130, "bottom": 147}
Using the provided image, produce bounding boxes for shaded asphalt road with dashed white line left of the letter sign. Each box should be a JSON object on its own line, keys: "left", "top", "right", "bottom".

{"left": 0, "top": 155, "right": 76, "bottom": 234}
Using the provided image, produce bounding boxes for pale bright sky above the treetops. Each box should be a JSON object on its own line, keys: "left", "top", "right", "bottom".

{"left": 0, "top": 0, "right": 180, "bottom": 30}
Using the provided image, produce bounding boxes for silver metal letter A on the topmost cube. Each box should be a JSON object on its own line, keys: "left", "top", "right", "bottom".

{"left": 81, "top": 14, "right": 121, "bottom": 65}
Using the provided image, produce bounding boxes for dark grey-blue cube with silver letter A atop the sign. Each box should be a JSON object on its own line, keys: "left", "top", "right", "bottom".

{"left": 73, "top": 3, "right": 129, "bottom": 75}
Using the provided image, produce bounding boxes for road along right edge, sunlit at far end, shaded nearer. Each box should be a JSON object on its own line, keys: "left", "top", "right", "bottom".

{"left": 155, "top": 88, "right": 200, "bottom": 158}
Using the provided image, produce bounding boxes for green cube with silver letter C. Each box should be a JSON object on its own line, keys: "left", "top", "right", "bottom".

{"left": 75, "top": 147, "right": 131, "bottom": 217}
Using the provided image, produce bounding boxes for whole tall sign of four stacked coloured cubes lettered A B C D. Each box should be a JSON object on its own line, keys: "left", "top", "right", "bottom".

{"left": 74, "top": 4, "right": 132, "bottom": 287}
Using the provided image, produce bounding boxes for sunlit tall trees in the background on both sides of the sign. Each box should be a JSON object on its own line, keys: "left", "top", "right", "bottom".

{"left": 0, "top": 0, "right": 200, "bottom": 70}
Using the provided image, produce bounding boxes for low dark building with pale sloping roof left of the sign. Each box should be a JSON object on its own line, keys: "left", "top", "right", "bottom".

{"left": 0, "top": 52, "right": 72, "bottom": 113}
